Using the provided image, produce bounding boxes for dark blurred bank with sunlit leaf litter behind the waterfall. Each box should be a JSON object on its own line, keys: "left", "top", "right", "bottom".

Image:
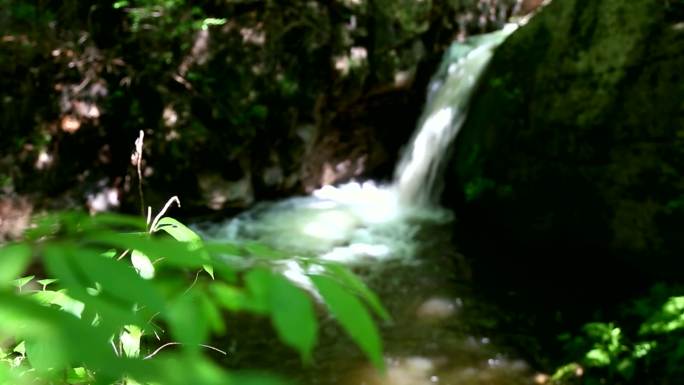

{"left": 0, "top": 0, "right": 518, "bottom": 210}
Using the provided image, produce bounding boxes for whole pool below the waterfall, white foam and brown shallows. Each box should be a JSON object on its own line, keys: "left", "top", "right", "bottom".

{"left": 199, "top": 183, "right": 544, "bottom": 385}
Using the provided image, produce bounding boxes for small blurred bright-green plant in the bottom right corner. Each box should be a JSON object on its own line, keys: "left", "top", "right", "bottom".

{"left": 553, "top": 285, "right": 684, "bottom": 385}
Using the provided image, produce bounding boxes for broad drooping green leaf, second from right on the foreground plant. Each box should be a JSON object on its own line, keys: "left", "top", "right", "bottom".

{"left": 245, "top": 269, "right": 318, "bottom": 362}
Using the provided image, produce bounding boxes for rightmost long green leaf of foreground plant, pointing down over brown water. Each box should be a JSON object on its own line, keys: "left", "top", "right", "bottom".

{"left": 311, "top": 275, "right": 384, "bottom": 368}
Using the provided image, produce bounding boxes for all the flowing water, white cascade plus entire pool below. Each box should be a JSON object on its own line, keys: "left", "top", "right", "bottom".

{"left": 196, "top": 23, "right": 534, "bottom": 385}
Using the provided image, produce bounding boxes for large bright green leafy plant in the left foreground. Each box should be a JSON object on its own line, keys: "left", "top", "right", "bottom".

{"left": 0, "top": 205, "right": 388, "bottom": 385}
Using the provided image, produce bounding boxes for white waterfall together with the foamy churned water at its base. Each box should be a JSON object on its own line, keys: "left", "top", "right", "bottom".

{"left": 197, "top": 25, "right": 516, "bottom": 263}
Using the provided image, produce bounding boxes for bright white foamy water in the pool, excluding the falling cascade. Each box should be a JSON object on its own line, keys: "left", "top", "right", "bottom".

{"left": 200, "top": 182, "right": 451, "bottom": 264}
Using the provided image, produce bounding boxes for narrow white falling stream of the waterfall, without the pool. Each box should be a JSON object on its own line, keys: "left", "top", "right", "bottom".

{"left": 394, "top": 24, "right": 517, "bottom": 206}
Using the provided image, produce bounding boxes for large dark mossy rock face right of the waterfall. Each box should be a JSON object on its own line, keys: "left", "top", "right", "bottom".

{"left": 444, "top": 0, "right": 684, "bottom": 278}
